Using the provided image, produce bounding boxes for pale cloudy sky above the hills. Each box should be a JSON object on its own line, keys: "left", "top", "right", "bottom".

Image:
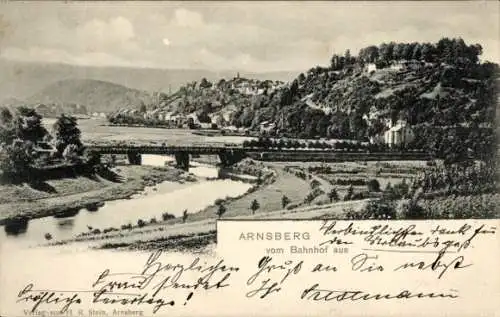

{"left": 0, "top": 0, "right": 500, "bottom": 72}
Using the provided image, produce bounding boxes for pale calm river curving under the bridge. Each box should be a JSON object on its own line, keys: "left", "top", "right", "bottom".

{"left": 0, "top": 155, "right": 252, "bottom": 246}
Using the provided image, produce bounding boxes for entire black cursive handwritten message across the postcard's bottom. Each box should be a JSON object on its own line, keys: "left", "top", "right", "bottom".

{"left": 17, "top": 221, "right": 496, "bottom": 313}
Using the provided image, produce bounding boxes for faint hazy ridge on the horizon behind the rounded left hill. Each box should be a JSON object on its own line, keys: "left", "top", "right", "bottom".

{"left": 0, "top": 59, "right": 299, "bottom": 101}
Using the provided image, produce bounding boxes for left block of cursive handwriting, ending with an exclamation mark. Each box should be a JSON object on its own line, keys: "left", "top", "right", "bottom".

{"left": 17, "top": 250, "right": 239, "bottom": 313}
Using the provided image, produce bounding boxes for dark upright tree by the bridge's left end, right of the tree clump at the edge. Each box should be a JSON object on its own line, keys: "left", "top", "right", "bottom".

{"left": 53, "top": 114, "right": 82, "bottom": 154}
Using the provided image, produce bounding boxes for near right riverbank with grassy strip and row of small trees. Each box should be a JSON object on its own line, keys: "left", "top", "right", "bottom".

{"left": 37, "top": 160, "right": 344, "bottom": 251}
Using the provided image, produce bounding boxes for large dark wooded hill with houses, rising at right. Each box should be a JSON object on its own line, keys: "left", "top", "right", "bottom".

{"left": 110, "top": 38, "right": 499, "bottom": 160}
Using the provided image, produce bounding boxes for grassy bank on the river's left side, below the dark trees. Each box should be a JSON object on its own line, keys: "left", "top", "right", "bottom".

{"left": 0, "top": 165, "right": 196, "bottom": 225}
